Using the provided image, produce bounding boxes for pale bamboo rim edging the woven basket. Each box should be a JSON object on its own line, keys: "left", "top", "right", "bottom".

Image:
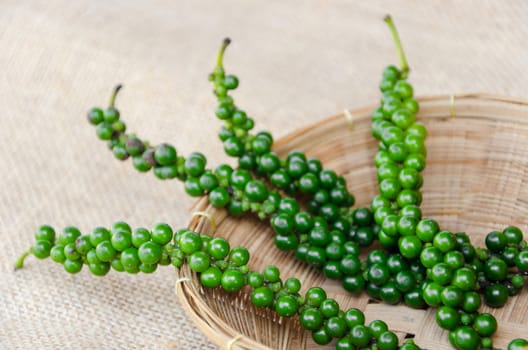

{"left": 175, "top": 93, "right": 528, "bottom": 350}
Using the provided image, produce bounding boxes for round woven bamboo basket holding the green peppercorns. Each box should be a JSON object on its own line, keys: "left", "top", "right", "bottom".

{"left": 176, "top": 94, "right": 528, "bottom": 350}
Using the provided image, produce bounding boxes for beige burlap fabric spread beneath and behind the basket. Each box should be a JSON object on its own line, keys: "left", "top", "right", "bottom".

{"left": 0, "top": 0, "right": 528, "bottom": 349}
